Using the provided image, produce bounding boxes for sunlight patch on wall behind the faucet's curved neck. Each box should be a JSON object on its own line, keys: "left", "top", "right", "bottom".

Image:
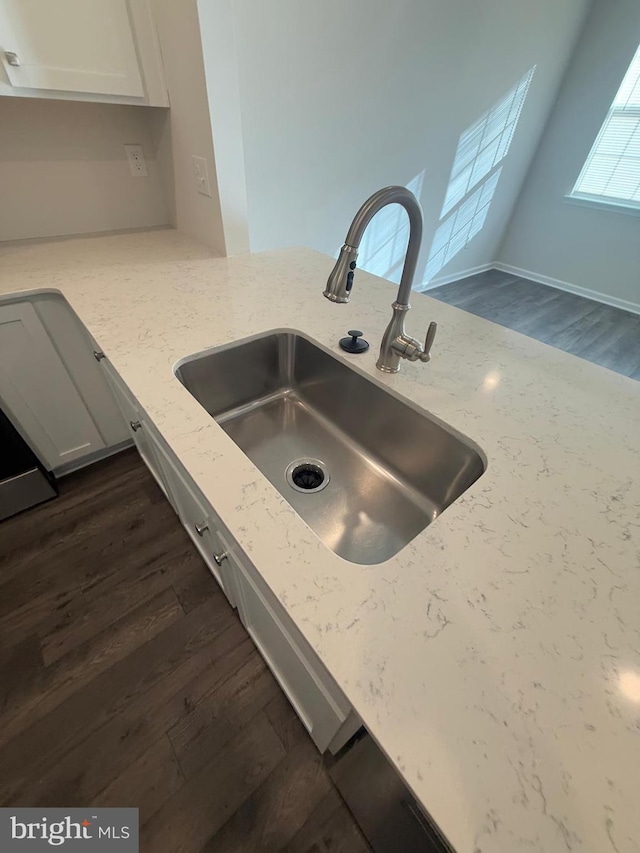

{"left": 358, "top": 170, "right": 424, "bottom": 284}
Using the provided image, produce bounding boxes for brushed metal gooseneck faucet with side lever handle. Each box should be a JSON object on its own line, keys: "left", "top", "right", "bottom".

{"left": 324, "top": 187, "right": 437, "bottom": 373}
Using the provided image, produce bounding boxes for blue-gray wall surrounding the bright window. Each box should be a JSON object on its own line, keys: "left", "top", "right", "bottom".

{"left": 496, "top": 0, "right": 640, "bottom": 306}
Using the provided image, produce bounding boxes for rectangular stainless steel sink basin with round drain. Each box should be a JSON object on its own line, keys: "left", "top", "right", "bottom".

{"left": 175, "top": 329, "right": 485, "bottom": 564}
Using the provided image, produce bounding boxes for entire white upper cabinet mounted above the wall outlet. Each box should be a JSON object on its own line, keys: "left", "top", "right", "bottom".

{"left": 0, "top": 0, "right": 168, "bottom": 106}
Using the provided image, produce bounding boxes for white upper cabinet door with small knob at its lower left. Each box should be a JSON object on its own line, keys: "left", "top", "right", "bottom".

{"left": 0, "top": 0, "right": 145, "bottom": 97}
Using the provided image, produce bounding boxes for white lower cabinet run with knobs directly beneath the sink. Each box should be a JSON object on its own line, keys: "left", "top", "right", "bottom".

{"left": 101, "top": 359, "right": 361, "bottom": 752}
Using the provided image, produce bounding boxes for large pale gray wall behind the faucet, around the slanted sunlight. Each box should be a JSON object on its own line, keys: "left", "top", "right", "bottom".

{"left": 229, "top": 0, "right": 589, "bottom": 280}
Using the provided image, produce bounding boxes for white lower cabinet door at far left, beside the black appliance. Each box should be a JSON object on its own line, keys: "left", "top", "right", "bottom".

{"left": 0, "top": 302, "right": 105, "bottom": 470}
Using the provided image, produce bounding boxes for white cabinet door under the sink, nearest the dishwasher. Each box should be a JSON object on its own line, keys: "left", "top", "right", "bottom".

{"left": 230, "top": 549, "right": 351, "bottom": 752}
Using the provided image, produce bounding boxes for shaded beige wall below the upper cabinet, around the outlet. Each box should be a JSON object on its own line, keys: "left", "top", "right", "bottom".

{"left": 0, "top": 97, "right": 170, "bottom": 241}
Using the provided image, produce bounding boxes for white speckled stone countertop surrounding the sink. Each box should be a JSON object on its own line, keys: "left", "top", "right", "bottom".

{"left": 0, "top": 231, "right": 640, "bottom": 853}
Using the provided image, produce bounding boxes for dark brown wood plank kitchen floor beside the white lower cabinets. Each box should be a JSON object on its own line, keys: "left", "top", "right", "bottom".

{"left": 0, "top": 450, "right": 369, "bottom": 853}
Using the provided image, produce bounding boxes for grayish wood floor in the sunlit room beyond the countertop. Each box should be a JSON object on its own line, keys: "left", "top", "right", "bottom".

{"left": 427, "top": 270, "right": 640, "bottom": 379}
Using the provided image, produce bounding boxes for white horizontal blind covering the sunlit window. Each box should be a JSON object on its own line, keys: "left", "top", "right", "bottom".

{"left": 571, "top": 47, "right": 640, "bottom": 208}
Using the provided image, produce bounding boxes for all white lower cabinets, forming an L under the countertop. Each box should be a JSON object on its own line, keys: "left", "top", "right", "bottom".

{"left": 0, "top": 297, "right": 360, "bottom": 752}
